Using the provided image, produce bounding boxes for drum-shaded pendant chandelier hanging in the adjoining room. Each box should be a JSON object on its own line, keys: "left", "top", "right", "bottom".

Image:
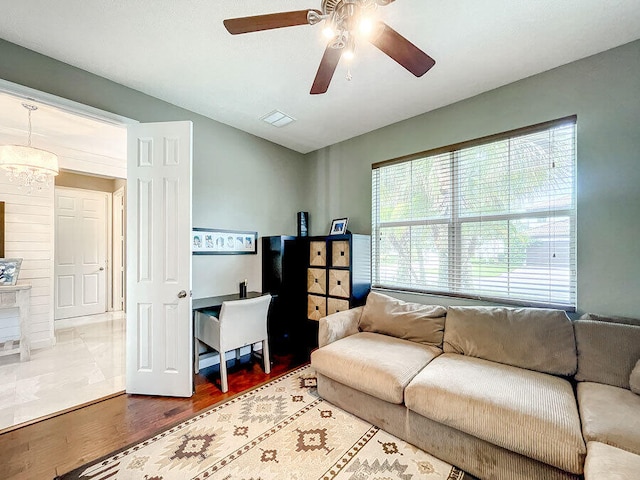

{"left": 0, "top": 103, "right": 58, "bottom": 193}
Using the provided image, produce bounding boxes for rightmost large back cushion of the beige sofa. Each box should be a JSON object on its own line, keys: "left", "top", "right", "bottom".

{"left": 574, "top": 320, "right": 640, "bottom": 389}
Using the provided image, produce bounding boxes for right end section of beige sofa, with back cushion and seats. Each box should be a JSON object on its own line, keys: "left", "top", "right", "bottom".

{"left": 574, "top": 315, "right": 640, "bottom": 480}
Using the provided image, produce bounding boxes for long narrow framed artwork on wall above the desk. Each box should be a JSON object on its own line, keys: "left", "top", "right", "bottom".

{"left": 191, "top": 228, "right": 258, "bottom": 255}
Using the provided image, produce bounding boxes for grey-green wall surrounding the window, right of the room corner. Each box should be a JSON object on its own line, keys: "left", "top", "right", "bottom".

{"left": 306, "top": 41, "right": 640, "bottom": 318}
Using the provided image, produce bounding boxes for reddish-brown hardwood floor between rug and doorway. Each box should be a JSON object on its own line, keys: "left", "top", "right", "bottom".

{"left": 0, "top": 355, "right": 304, "bottom": 480}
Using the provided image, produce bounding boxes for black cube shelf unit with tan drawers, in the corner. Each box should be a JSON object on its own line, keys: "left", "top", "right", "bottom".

{"left": 262, "top": 234, "right": 371, "bottom": 360}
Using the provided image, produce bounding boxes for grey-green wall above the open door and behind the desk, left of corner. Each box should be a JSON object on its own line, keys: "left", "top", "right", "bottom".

{"left": 0, "top": 40, "right": 310, "bottom": 298}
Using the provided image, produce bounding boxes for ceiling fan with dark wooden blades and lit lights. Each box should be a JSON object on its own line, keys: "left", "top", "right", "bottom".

{"left": 224, "top": 0, "right": 436, "bottom": 95}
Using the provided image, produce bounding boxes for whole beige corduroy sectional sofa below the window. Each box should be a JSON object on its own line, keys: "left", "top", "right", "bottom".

{"left": 311, "top": 292, "right": 640, "bottom": 480}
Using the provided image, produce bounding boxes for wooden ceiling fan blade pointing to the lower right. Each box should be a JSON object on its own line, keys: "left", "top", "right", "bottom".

{"left": 370, "top": 22, "right": 436, "bottom": 77}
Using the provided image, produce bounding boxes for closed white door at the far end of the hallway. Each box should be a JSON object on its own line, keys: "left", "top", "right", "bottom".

{"left": 54, "top": 187, "right": 109, "bottom": 320}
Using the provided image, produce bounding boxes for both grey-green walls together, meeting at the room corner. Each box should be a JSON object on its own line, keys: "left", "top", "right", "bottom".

{"left": 0, "top": 40, "right": 640, "bottom": 317}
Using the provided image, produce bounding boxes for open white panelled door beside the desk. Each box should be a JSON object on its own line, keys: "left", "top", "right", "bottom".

{"left": 126, "top": 122, "right": 193, "bottom": 397}
